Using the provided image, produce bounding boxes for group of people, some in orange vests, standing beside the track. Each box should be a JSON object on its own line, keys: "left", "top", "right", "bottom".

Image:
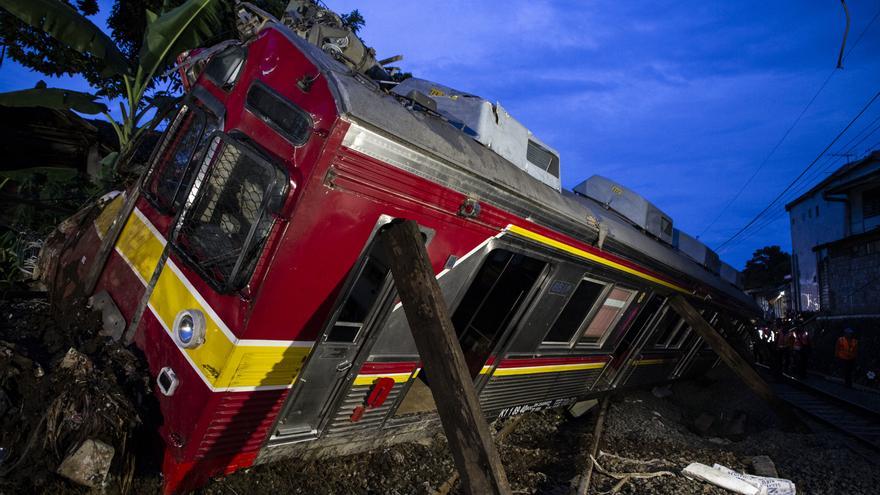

{"left": 754, "top": 318, "right": 859, "bottom": 388}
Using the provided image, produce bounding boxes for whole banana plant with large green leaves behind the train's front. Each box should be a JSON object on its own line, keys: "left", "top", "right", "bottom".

{"left": 0, "top": 0, "right": 231, "bottom": 170}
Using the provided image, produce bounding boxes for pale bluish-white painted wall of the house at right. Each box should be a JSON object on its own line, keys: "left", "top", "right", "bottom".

{"left": 788, "top": 197, "right": 847, "bottom": 311}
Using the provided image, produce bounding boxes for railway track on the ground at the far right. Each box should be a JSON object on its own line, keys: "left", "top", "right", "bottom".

{"left": 765, "top": 373, "right": 880, "bottom": 450}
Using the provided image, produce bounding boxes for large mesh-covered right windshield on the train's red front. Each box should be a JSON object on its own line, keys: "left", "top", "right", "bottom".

{"left": 177, "top": 136, "right": 287, "bottom": 291}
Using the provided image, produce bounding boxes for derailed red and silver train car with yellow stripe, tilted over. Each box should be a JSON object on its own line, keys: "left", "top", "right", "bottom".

{"left": 53, "top": 5, "right": 757, "bottom": 492}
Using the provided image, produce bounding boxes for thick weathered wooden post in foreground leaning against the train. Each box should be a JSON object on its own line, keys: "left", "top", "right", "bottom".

{"left": 381, "top": 220, "right": 510, "bottom": 495}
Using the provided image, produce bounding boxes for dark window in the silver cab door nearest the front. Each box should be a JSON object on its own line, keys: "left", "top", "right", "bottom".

{"left": 326, "top": 246, "right": 389, "bottom": 342}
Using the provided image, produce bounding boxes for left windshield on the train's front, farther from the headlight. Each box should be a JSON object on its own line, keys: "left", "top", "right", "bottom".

{"left": 146, "top": 105, "right": 216, "bottom": 213}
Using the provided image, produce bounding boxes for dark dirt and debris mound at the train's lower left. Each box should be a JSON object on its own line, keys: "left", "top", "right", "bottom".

{"left": 0, "top": 300, "right": 159, "bottom": 493}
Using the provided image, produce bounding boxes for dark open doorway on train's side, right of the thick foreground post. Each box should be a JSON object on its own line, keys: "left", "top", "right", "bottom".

{"left": 452, "top": 249, "right": 546, "bottom": 377}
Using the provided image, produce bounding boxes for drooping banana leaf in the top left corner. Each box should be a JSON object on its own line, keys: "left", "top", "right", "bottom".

{"left": 0, "top": 0, "right": 129, "bottom": 77}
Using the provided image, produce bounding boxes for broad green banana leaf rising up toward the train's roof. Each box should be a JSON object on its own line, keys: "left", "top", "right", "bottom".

{"left": 138, "top": 0, "right": 229, "bottom": 85}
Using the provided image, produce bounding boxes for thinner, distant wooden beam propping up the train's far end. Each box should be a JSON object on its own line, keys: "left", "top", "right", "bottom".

{"left": 669, "top": 295, "right": 802, "bottom": 425}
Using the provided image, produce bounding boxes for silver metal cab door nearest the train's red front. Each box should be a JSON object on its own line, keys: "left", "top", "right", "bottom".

{"left": 276, "top": 226, "right": 395, "bottom": 441}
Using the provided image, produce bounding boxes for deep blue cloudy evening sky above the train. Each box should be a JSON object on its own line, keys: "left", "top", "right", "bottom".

{"left": 0, "top": 0, "right": 880, "bottom": 268}
